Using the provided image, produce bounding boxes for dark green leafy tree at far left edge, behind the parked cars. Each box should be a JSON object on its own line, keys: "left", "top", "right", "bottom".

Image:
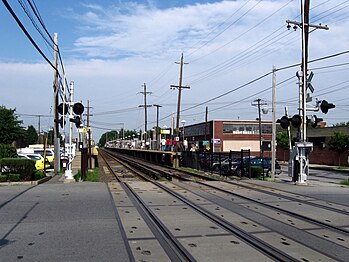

{"left": 0, "top": 106, "right": 25, "bottom": 145}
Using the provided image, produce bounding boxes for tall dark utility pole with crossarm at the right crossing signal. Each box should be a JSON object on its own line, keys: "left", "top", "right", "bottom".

{"left": 286, "top": 0, "right": 329, "bottom": 184}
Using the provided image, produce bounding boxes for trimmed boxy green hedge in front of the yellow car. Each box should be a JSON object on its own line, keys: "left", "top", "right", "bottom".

{"left": 0, "top": 158, "right": 36, "bottom": 180}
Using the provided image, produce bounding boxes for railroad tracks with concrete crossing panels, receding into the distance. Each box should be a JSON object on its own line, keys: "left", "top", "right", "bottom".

{"left": 97, "top": 148, "right": 349, "bottom": 261}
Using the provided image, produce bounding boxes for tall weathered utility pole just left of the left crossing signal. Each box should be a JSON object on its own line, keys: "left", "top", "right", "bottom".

{"left": 53, "top": 33, "right": 60, "bottom": 174}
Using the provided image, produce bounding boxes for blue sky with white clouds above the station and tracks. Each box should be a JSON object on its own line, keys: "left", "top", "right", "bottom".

{"left": 0, "top": 0, "right": 349, "bottom": 142}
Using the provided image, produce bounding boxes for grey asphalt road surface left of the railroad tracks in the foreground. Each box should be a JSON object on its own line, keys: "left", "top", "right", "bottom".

{"left": 0, "top": 180, "right": 129, "bottom": 261}
